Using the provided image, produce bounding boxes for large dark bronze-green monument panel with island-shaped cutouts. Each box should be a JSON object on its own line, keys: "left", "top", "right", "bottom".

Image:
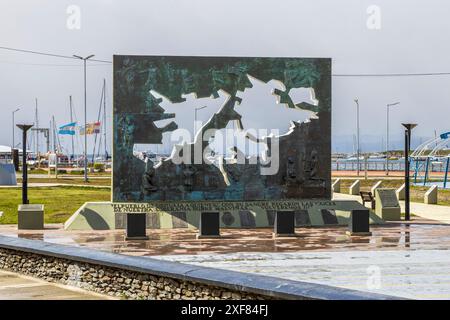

{"left": 113, "top": 57, "right": 331, "bottom": 202}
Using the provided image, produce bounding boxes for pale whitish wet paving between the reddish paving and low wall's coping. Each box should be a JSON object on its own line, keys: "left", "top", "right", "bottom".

{"left": 153, "top": 250, "right": 450, "bottom": 300}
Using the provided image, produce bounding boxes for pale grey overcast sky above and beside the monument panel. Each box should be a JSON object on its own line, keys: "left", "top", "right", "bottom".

{"left": 0, "top": 0, "right": 450, "bottom": 151}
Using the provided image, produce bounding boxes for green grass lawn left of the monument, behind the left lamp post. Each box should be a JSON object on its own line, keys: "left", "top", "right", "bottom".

{"left": 0, "top": 187, "right": 111, "bottom": 224}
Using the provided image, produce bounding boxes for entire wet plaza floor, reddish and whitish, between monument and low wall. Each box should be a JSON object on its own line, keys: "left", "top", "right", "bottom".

{"left": 0, "top": 217, "right": 450, "bottom": 299}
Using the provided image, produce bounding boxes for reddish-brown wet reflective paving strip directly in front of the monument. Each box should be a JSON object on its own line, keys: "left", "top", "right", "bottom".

{"left": 0, "top": 220, "right": 450, "bottom": 256}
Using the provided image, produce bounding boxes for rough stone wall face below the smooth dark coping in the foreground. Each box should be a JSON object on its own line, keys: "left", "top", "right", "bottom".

{"left": 0, "top": 248, "right": 271, "bottom": 300}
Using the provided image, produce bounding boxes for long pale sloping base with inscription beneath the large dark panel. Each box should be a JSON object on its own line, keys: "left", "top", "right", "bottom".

{"left": 64, "top": 200, "right": 383, "bottom": 230}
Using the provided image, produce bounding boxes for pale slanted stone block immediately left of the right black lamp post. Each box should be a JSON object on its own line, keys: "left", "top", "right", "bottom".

{"left": 375, "top": 188, "right": 401, "bottom": 221}
